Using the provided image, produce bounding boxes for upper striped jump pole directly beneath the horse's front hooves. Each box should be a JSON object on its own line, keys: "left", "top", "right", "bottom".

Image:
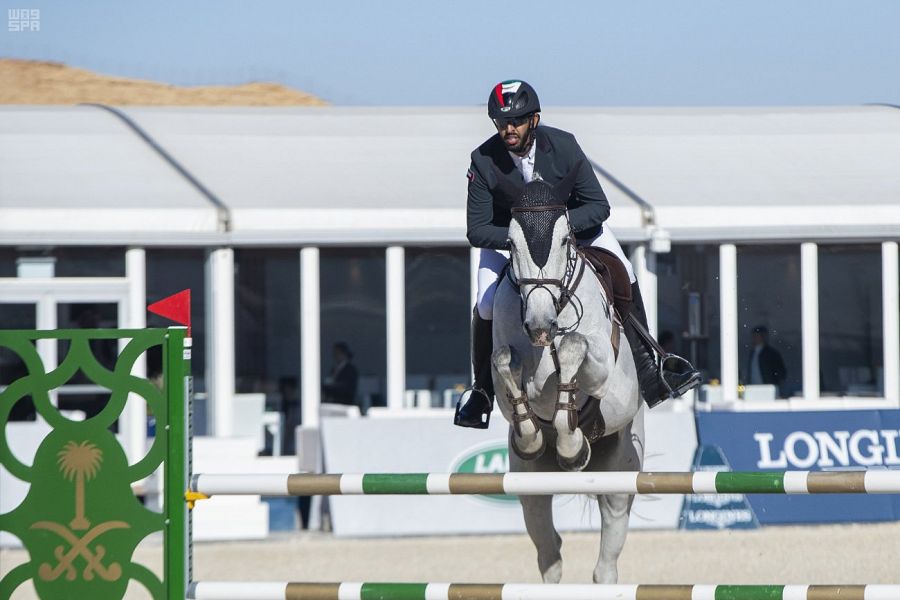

{"left": 190, "top": 470, "right": 900, "bottom": 497}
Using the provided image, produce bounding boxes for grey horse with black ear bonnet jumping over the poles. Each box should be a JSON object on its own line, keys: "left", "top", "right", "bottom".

{"left": 491, "top": 177, "right": 644, "bottom": 584}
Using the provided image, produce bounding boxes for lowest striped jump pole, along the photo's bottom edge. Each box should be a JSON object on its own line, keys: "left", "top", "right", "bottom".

{"left": 187, "top": 581, "right": 900, "bottom": 600}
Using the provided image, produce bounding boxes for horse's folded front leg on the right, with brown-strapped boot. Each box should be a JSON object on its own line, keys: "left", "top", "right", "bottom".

{"left": 553, "top": 333, "right": 591, "bottom": 471}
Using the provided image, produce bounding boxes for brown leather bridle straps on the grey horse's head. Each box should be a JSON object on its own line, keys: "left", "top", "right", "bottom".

{"left": 506, "top": 204, "right": 587, "bottom": 336}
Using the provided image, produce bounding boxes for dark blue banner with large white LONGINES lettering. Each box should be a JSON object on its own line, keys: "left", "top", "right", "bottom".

{"left": 697, "top": 410, "right": 900, "bottom": 525}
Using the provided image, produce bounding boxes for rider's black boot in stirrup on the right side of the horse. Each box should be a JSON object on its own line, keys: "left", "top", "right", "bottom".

{"left": 625, "top": 282, "right": 700, "bottom": 408}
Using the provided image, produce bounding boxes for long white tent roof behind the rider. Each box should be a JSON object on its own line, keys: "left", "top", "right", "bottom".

{"left": 0, "top": 106, "right": 900, "bottom": 245}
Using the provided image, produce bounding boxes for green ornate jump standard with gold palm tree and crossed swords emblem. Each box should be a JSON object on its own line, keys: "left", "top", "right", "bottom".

{"left": 0, "top": 328, "right": 191, "bottom": 600}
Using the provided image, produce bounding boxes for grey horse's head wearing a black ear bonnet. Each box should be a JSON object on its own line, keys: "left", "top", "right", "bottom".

{"left": 509, "top": 171, "right": 575, "bottom": 346}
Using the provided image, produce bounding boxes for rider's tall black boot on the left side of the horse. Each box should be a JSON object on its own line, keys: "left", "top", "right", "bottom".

{"left": 453, "top": 308, "right": 494, "bottom": 429}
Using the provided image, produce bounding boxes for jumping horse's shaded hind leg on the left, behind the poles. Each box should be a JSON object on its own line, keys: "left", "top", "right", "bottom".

{"left": 509, "top": 455, "right": 562, "bottom": 583}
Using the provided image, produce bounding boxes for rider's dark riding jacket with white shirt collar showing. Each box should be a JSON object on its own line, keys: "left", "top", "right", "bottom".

{"left": 466, "top": 125, "right": 609, "bottom": 250}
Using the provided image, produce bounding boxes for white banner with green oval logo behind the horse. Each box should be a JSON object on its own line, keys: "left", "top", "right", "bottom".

{"left": 322, "top": 410, "right": 697, "bottom": 536}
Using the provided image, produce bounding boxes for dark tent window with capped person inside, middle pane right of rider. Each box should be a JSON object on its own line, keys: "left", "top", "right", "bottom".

{"left": 737, "top": 245, "right": 803, "bottom": 398}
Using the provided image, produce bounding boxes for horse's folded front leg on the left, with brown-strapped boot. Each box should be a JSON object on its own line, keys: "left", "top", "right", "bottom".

{"left": 491, "top": 346, "right": 546, "bottom": 460}
